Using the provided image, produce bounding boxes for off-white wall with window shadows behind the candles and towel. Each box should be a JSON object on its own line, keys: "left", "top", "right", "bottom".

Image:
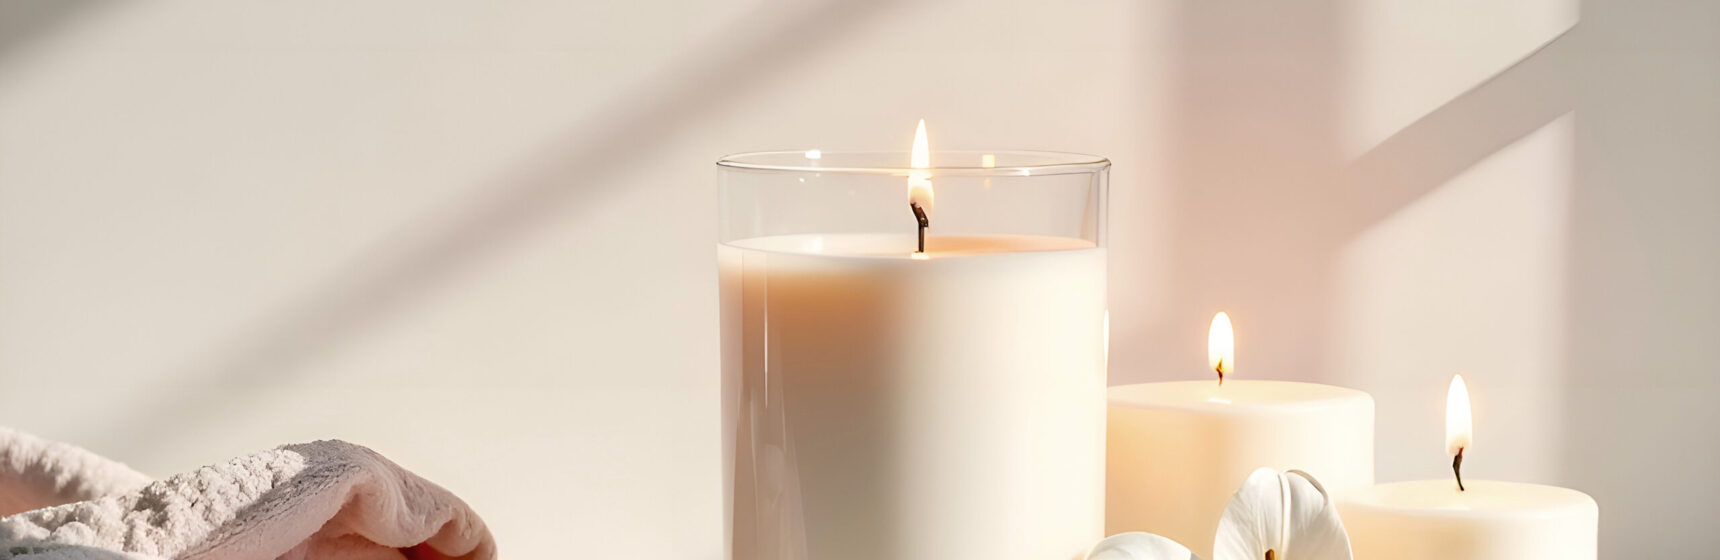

{"left": 0, "top": 0, "right": 1720, "bottom": 558}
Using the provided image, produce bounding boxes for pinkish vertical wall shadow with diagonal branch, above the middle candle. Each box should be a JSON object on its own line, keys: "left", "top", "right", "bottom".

{"left": 1147, "top": 2, "right": 1579, "bottom": 381}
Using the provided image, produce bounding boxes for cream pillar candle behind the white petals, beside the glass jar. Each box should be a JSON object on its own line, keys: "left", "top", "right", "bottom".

{"left": 1104, "top": 378, "right": 1374, "bottom": 558}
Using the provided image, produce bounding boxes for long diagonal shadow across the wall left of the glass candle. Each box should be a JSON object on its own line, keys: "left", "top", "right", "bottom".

{"left": 94, "top": 0, "right": 891, "bottom": 457}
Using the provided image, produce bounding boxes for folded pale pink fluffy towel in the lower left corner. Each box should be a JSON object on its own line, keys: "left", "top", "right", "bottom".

{"left": 0, "top": 429, "right": 495, "bottom": 560}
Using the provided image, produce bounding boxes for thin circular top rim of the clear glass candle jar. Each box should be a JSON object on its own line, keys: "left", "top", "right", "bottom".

{"left": 717, "top": 149, "right": 1111, "bottom": 177}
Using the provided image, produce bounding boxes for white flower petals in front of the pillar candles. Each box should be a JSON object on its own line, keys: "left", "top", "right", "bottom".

{"left": 1087, "top": 469, "right": 1352, "bottom": 560}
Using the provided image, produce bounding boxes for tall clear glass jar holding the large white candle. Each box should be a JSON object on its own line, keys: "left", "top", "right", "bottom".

{"left": 717, "top": 151, "right": 1109, "bottom": 560}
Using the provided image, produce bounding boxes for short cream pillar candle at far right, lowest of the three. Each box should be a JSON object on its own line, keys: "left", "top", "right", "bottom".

{"left": 1338, "top": 479, "right": 1600, "bottom": 560}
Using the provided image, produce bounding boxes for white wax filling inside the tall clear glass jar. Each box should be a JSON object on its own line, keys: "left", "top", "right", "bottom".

{"left": 719, "top": 234, "right": 1106, "bottom": 560}
